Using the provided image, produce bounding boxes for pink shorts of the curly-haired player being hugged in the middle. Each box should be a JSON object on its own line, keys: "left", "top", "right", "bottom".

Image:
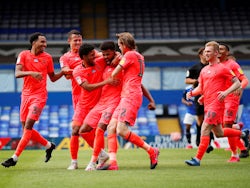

{"left": 84, "top": 103, "right": 118, "bottom": 128}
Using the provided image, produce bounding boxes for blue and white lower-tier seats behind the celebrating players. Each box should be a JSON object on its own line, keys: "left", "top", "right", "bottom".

{"left": 0, "top": 105, "right": 159, "bottom": 138}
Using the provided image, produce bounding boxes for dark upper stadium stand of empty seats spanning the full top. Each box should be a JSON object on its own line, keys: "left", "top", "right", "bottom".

{"left": 0, "top": 0, "right": 250, "bottom": 41}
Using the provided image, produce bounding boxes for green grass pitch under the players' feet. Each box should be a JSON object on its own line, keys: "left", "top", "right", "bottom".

{"left": 0, "top": 149, "right": 250, "bottom": 188}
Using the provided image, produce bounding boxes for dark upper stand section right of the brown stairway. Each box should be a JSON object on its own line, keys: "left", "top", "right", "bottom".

{"left": 108, "top": 0, "right": 250, "bottom": 39}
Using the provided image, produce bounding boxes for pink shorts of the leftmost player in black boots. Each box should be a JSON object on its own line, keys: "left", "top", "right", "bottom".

{"left": 20, "top": 96, "right": 47, "bottom": 122}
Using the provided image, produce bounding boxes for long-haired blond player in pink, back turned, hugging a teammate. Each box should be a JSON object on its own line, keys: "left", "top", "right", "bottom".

{"left": 99, "top": 32, "right": 159, "bottom": 170}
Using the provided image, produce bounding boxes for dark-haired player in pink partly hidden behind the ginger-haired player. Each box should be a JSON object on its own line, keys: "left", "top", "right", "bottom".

{"left": 219, "top": 43, "right": 249, "bottom": 162}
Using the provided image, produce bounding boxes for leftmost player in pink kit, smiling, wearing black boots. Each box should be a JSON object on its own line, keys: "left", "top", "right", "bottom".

{"left": 2, "top": 32, "right": 67, "bottom": 167}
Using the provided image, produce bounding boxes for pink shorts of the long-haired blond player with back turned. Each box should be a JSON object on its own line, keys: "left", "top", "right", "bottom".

{"left": 112, "top": 98, "right": 142, "bottom": 126}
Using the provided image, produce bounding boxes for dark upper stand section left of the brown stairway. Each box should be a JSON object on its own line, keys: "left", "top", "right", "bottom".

{"left": 0, "top": 0, "right": 80, "bottom": 41}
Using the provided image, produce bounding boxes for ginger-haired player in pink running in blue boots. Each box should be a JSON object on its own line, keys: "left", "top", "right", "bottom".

{"left": 185, "top": 41, "right": 249, "bottom": 166}
